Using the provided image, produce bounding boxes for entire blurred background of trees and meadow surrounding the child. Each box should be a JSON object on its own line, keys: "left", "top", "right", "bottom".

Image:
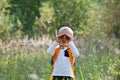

{"left": 0, "top": 0, "right": 120, "bottom": 80}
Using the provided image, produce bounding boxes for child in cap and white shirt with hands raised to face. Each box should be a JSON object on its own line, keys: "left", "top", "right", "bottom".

{"left": 47, "top": 27, "right": 79, "bottom": 80}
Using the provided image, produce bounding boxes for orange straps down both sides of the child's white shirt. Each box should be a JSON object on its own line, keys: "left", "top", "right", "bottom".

{"left": 50, "top": 46, "right": 76, "bottom": 80}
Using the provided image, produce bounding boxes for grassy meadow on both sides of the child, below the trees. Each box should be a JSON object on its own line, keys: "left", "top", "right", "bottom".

{"left": 0, "top": 36, "right": 120, "bottom": 80}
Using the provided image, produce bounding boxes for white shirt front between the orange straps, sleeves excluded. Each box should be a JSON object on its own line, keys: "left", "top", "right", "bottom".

{"left": 52, "top": 48, "right": 74, "bottom": 77}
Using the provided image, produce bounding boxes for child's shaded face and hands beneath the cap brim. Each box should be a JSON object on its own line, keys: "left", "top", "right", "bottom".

{"left": 58, "top": 34, "right": 70, "bottom": 47}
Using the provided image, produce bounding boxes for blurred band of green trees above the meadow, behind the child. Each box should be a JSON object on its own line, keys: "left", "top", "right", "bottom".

{"left": 0, "top": 0, "right": 120, "bottom": 38}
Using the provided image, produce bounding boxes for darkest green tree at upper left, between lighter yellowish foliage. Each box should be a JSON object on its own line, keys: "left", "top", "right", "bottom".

{"left": 7, "top": 0, "right": 41, "bottom": 36}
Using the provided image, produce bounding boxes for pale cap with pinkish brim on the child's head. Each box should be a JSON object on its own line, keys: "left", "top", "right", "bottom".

{"left": 58, "top": 26, "right": 73, "bottom": 39}
